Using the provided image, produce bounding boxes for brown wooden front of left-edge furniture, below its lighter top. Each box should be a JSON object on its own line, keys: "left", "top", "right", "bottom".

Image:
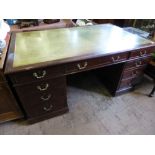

{"left": 0, "top": 83, "right": 22, "bottom": 122}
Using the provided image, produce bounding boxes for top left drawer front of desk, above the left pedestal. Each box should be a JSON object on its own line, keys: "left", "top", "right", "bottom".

{"left": 9, "top": 66, "right": 64, "bottom": 84}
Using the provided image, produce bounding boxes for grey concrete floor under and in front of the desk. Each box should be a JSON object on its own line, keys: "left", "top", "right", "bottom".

{"left": 0, "top": 72, "right": 155, "bottom": 135}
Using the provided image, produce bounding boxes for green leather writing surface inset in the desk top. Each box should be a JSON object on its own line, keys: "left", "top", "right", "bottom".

{"left": 13, "top": 24, "right": 154, "bottom": 67}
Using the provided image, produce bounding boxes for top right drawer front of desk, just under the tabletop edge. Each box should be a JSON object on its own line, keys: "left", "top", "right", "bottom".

{"left": 130, "top": 48, "right": 154, "bottom": 59}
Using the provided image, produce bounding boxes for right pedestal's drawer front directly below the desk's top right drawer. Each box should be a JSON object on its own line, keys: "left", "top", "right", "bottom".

{"left": 125, "top": 58, "right": 149, "bottom": 69}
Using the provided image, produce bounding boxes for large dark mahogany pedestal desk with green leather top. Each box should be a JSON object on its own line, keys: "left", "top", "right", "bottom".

{"left": 5, "top": 24, "right": 155, "bottom": 123}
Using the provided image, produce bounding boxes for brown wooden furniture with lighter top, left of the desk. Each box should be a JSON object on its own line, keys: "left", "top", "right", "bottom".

{"left": 0, "top": 34, "right": 23, "bottom": 123}
